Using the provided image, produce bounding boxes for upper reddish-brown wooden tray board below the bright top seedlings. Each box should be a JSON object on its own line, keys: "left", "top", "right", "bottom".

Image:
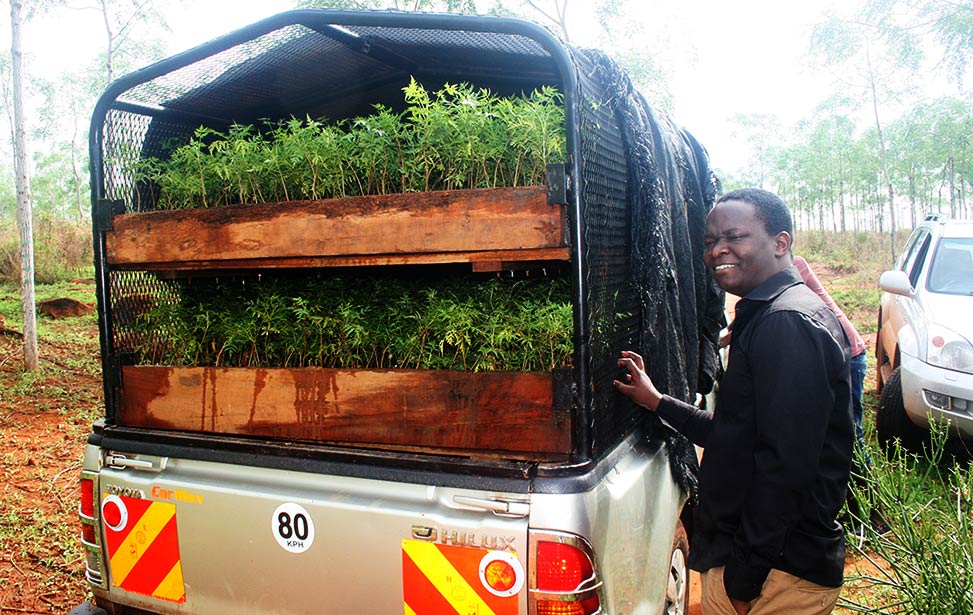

{"left": 105, "top": 187, "right": 566, "bottom": 267}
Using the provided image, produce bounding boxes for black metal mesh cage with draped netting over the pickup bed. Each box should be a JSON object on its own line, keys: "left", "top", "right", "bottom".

{"left": 90, "top": 10, "right": 721, "bottom": 472}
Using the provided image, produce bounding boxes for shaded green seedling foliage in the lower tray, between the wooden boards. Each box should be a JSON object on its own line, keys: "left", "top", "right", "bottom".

{"left": 129, "top": 277, "right": 573, "bottom": 371}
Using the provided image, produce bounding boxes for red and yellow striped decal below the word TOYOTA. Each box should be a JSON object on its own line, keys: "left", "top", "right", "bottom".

{"left": 105, "top": 496, "right": 186, "bottom": 602}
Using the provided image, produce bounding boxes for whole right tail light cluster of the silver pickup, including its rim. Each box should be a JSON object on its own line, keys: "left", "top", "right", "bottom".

{"left": 530, "top": 531, "right": 602, "bottom": 615}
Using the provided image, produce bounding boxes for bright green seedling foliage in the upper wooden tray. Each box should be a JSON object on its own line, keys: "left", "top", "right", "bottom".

{"left": 135, "top": 79, "right": 566, "bottom": 209}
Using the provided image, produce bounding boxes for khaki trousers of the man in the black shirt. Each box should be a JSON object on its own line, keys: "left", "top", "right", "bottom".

{"left": 700, "top": 566, "right": 841, "bottom": 615}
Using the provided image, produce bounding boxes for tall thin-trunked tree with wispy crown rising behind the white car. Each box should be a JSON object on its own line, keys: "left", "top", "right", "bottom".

{"left": 811, "top": 15, "right": 922, "bottom": 257}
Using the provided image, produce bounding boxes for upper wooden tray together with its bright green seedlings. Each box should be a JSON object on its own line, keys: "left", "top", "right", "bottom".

{"left": 105, "top": 80, "right": 569, "bottom": 271}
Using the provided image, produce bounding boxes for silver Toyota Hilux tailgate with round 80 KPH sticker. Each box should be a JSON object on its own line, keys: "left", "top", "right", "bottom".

{"left": 97, "top": 454, "right": 529, "bottom": 615}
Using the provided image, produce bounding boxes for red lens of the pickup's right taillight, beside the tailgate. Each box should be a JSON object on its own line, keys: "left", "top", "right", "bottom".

{"left": 535, "top": 540, "right": 601, "bottom": 615}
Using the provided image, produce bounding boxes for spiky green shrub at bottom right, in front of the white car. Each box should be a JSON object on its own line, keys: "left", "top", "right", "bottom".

{"left": 842, "top": 422, "right": 973, "bottom": 615}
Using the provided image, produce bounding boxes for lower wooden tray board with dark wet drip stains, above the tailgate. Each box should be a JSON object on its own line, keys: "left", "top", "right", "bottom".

{"left": 116, "top": 366, "right": 571, "bottom": 455}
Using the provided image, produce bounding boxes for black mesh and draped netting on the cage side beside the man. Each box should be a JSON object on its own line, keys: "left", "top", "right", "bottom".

{"left": 576, "top": 51, "right": 722, "bottom": 502}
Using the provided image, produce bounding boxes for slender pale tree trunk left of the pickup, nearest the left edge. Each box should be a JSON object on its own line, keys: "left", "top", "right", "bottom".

{"left": 10, "top": 0, "right": 38, "bottom": 371}
